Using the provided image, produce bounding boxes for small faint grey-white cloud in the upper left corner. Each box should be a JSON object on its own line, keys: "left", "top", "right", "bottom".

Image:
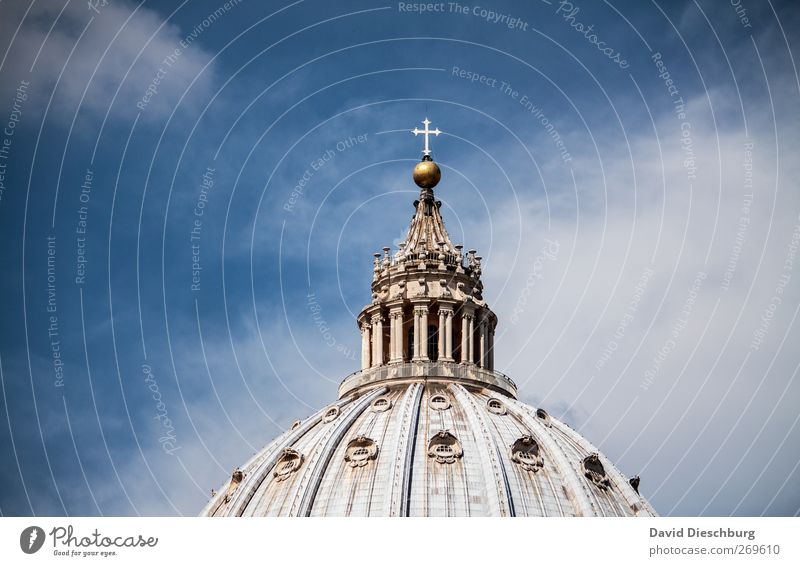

{"left": 0, "top": 2, "right": 217, "bottom": 122}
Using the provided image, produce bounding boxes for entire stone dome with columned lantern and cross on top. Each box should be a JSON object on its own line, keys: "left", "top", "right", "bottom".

{"left": 202, "top": 118, "right": 655, "bottom": 517}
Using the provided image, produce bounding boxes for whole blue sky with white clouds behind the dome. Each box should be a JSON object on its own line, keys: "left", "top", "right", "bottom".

{"left": 0, "top": 0, "right": 800, "bottom": 516}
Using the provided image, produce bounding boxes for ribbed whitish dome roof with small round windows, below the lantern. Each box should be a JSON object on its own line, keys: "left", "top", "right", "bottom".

{"left": 203, "top": 362, "right": 655, "bottom": 517}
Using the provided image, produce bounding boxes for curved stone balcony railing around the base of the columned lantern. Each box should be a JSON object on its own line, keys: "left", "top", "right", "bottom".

{"left": 339, "top": 362, "right": 517, "bottom": 399}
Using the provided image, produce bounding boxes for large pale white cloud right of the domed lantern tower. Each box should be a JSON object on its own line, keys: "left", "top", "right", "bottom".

{"left": 476, "top": 83, "right": 800, "bottom": 515}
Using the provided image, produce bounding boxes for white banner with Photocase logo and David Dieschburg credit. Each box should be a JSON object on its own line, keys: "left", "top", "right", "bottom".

{"left": 0, "top": 517, "right": 800, "bottom": 566}
